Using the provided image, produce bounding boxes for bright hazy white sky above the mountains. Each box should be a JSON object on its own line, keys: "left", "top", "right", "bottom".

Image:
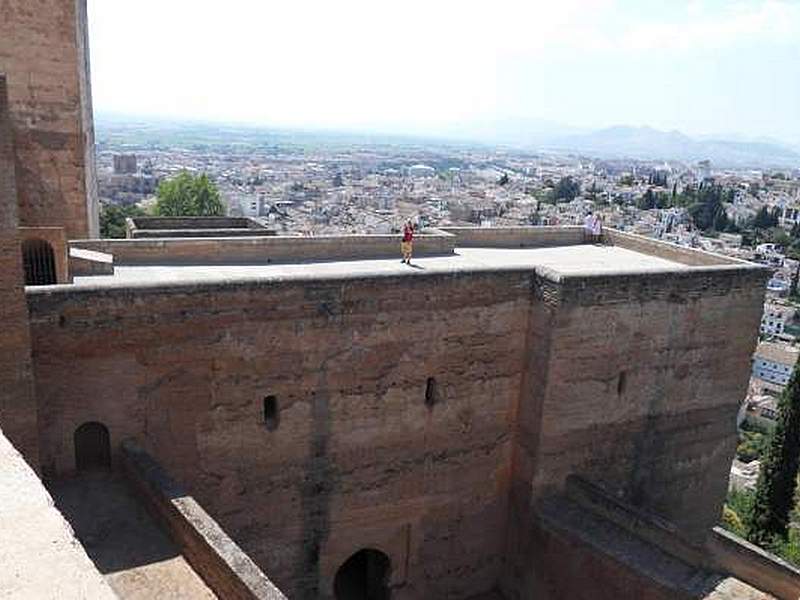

{"left": 89, "top": 0, "right": 800, "bottom": 144}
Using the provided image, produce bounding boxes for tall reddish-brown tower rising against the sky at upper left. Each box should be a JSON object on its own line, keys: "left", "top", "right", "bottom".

{"left": 0, "top": 0, "right": 99, "bottom": 238}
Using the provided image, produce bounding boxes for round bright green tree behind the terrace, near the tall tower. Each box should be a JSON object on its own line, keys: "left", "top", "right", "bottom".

{"left": 156, "top": 171, "right": 225, "bottom": 217}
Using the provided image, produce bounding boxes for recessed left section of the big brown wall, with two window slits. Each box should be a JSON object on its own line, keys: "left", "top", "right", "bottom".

{"left": 29, "top": 272, "right": 531, "bottom": 598}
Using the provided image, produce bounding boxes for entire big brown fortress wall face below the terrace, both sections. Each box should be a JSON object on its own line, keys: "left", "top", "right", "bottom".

{"left": 28, "top": 246, "right": 765, "bottom": 598}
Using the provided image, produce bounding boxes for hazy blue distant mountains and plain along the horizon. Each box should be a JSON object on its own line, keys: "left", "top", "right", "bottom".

{"left": 97, "top": 115, "right": 800, "bottom": 169}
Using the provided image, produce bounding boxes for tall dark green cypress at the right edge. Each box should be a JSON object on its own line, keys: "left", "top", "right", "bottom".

{"left": 747, "top": 369, "right": 800, "bottom": 547}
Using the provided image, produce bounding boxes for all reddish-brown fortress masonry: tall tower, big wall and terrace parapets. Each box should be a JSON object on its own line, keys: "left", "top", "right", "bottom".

{"left": 0, "top": 0, "right": 800, "bottom": 600}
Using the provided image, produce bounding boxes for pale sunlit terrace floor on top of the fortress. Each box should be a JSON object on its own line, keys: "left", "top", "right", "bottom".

{"left": 65, "top": 245, "right": 708, "bottom": 287}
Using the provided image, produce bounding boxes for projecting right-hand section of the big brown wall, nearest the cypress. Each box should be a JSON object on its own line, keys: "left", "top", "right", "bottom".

{"left": 503, "top": 269, "right": 766, "bottom": 598}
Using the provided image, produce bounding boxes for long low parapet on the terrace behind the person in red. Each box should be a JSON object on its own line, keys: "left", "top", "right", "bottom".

{"left": 70, "top": 230, "right": 455, "bottom": 265}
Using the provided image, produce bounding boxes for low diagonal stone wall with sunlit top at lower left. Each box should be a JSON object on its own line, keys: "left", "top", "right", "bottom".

{"left": 122, "top": 440, "right": 286, "bottom": 600}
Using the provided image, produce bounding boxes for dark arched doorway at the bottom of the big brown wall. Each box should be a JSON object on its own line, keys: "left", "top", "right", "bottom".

{"left": 333, "top": 548, "right": 392, "bottom": 600}
